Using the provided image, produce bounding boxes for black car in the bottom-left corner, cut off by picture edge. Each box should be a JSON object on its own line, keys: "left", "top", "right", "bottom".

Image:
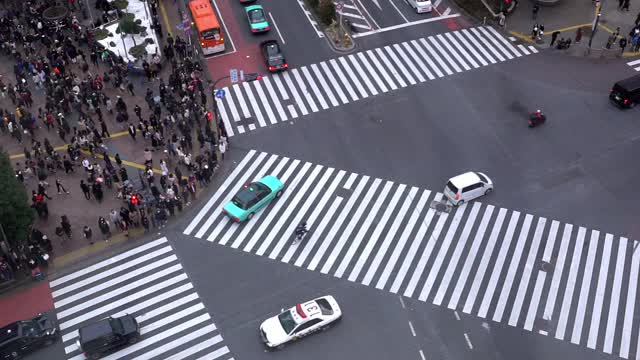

{"left": 0, "top": 314, "right": 59, "bottom": 359}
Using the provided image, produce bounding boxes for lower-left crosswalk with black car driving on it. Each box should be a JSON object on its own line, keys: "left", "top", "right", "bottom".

{"left": 50, "top": 238, "right": 233, "bottom": 360}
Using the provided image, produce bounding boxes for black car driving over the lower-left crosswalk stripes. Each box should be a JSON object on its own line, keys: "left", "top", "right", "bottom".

{"left": 78, "top": 314, "right": 140, "bottom": 359}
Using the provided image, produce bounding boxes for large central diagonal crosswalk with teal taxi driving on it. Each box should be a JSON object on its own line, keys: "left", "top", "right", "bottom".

{"left": 184, "top": 150, "right": 640, "bottom": 359}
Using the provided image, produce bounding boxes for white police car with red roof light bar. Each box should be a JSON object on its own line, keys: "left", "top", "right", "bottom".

{"left": 260, "top": 295, "right": 342, "bottom": 348}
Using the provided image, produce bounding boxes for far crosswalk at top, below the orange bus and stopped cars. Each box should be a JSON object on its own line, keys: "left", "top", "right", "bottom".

{"left": 217, "top": 26, "right": 537, "bottom": 136}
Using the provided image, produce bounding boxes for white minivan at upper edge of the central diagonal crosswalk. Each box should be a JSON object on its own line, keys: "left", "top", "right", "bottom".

{"left": 444, "top": 171, "right": 493, "bottom": 206}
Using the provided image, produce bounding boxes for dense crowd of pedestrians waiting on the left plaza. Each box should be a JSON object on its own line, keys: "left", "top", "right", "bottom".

{"left": 0, "top": 0, "right": 228, "bottom": 282}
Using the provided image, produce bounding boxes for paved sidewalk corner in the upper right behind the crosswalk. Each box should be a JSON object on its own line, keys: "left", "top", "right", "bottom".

{"left": 506, "top": 0, "right": 640, "bottom": 58}
